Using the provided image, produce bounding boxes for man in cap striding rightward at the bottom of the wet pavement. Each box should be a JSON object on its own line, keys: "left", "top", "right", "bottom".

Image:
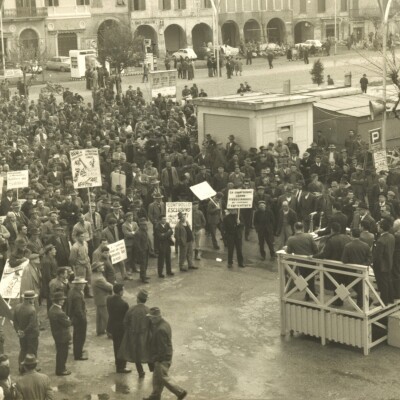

{"left": 143, "top": 307, "right": 187, "bottom": 400}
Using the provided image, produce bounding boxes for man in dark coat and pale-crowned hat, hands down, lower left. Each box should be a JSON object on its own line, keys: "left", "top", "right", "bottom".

{"left": 67, "top": 277, "right": 88, "bottom": 361}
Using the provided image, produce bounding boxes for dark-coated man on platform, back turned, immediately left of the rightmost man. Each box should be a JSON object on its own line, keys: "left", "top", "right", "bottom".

{"left": 342, "top": 228, "right": 372, "bottom": 309}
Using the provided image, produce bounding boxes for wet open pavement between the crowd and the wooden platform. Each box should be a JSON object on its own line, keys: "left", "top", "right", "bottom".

{"left": 4, "top": 232, "right": 400, "bottom": 400}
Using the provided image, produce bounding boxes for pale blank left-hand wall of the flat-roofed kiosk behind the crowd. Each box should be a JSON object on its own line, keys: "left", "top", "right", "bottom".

{"left": 204, "top": 114, "right": 251, "bottom": 148}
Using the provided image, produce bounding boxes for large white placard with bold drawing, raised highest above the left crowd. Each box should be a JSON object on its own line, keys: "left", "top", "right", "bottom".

{"left": 69, "top": 149, "right": 102, "bottom": 189}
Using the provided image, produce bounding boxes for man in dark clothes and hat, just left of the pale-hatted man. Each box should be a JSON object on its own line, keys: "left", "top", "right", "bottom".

{"left": 48, "top": 290, "right": 71, "bottom": 376}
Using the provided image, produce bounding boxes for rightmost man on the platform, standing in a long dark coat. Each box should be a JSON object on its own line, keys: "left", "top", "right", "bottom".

{"left": 372, "top": 218, "right": 395, "bottom": 305}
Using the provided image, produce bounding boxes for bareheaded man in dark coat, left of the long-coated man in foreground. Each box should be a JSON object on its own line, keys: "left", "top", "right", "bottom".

{"left": 107, "top": 283, "right": 131, "bottom": 374}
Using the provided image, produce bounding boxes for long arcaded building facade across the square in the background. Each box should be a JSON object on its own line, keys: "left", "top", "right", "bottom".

{"left": 3, "top": 0, "right": 400, "bottom": 58}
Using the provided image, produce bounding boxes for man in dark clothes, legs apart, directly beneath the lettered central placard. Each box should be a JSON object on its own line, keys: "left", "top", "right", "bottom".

{"left": 223, "top": 209, "right": 245, "bottom": 268}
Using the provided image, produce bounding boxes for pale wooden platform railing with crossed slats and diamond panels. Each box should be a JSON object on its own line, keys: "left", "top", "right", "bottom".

{"left": 278, "top": 251, "right": 400, "bottom": 355}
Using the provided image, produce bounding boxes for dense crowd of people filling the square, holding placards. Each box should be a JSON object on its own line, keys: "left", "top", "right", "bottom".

{"left": 0, "top": 74, "right": 400, "bottom": 399}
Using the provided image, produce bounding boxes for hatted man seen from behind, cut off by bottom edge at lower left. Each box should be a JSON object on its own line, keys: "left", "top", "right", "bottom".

{"left": 16, "top": 353, "right": 53, "bottom": 400}
